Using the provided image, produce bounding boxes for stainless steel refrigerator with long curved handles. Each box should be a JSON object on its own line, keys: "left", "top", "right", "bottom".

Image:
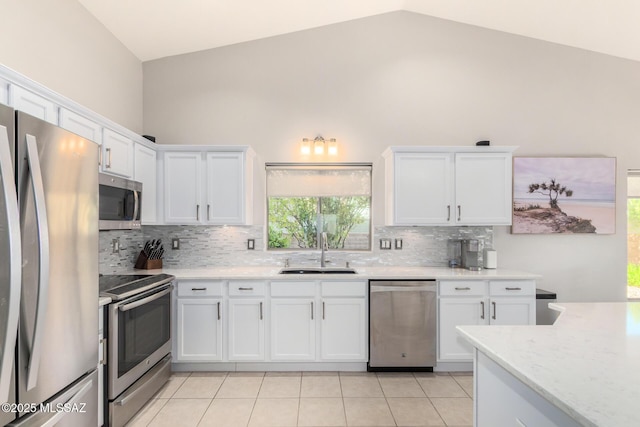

{"left": 0, "top": 105, "right": 98, "bottom": 427}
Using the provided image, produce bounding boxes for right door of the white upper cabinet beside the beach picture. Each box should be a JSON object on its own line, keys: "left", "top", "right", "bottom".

{"left": 455, "top": 153, "right": 512, "bottom": 225}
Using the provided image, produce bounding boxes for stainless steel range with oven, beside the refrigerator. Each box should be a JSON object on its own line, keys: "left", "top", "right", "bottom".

{"left": 100, "top": 274, "right": 175, "bottom": 426}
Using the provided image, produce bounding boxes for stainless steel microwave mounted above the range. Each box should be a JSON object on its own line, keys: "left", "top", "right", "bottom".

{"left": 98, "top": 173, "right": 142, "bottom": 230}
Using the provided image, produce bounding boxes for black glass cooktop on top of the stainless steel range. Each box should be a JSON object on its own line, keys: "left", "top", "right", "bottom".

{"left": 98, "top": 273, "right": 175, "bottom": 301}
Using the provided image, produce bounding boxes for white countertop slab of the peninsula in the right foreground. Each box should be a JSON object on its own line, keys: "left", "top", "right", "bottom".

{"left": 457, "top": 302, "right": 640, "bottom": 427}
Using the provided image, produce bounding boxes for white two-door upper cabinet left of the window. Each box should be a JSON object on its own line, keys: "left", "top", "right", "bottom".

{"left": 163, "top": 147, "right": 253, "bottom": 225}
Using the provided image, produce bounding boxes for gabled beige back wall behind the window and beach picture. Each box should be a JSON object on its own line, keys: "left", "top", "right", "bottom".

{"left": 143, "top": 12, "right": 640, "bottom": 301}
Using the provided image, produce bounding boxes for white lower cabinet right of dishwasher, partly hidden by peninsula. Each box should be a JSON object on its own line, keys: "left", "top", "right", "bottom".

{"left": 438, "top": 280, "right": 536, "bottom": 362}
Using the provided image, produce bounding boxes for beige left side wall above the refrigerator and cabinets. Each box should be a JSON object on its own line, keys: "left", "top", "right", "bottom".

{"left": 0, "top": 0, "right": 142, "bottom": 132}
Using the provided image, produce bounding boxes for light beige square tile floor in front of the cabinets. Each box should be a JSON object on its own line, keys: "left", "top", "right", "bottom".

{"left": 127, "top": 372, "right": 473, "bottom": 427}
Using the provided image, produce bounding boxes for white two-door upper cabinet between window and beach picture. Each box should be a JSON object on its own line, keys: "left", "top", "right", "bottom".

{"left": 383, "top": 147, "right": 514, "bottom": 225}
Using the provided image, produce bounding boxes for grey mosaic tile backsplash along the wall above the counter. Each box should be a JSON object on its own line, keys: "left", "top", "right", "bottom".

{"left": 100, "top": 225, "right": 493, "bottom": 274}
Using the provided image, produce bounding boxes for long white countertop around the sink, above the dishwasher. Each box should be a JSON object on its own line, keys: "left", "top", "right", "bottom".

{"left": 122, "top": 266, "right": 541, "bottom": 280}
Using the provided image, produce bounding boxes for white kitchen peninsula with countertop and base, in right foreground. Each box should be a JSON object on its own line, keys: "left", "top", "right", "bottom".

{"left": 457, "top": 303, "right": 640, "bottom": 427}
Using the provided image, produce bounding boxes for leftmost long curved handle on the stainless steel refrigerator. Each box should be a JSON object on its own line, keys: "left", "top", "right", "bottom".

{"left": 0, "top": 126, "right": 22, "bottom": 402}
